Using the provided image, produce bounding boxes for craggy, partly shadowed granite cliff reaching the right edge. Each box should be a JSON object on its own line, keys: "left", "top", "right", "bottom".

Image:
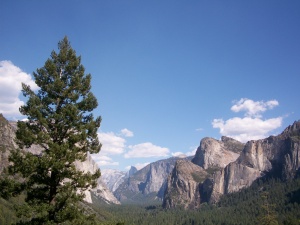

{"left": 210, "top": 121, "right": 300, "bottom": 202}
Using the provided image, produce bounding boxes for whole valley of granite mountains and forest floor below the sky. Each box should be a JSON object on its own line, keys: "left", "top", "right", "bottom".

{"left": 0, "top": 115, "right": 300, "bottom": 224}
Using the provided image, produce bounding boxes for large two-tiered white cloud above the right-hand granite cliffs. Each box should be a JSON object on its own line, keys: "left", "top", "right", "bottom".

{"left": 212, "top": 98, "right": 283, "bottom": 142}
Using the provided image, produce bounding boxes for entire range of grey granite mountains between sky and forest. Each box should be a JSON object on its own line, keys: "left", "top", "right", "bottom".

{"left": 0, "top": 114, "right": 300, "bottom": 209}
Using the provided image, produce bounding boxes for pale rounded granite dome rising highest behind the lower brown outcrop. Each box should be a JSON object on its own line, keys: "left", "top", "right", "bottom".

{"left": 192, "top": 136, "right": 244, "bottom": 169}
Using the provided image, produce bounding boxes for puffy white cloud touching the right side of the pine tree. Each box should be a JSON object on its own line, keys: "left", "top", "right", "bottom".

{"left": 98, "top": 132, "right": 126, "bottom": 155}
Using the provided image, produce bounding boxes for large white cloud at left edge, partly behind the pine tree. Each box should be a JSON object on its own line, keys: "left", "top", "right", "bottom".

{"left": 0, "top": 60, "right": 38, "bottom": 118}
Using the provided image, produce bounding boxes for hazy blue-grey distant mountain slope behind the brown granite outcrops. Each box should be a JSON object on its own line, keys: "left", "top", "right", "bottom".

{"left": 114, "top": 157, "right": 178, "bottom": 203}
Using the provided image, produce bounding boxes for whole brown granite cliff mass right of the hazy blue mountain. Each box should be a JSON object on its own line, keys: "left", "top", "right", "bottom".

{"left": 163, "top": 121, "right": 300, "bottom": 208}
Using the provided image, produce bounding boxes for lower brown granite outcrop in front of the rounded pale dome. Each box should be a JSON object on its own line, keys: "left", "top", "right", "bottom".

{"left": 163, "top": 160, "right": 208, "bottom": 209}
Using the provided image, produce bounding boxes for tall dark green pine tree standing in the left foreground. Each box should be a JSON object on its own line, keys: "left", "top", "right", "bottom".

{"left": 5, "top": 37, "right": 101, "bottom": 224}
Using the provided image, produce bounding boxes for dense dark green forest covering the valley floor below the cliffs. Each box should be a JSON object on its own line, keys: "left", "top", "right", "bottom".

{"left": 0, "top": 172, "right": 300, "bottom": 225}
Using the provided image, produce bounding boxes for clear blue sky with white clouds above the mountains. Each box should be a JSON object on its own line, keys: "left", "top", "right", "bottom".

{"left": 0, "top": 0, "right": 300, "bottom": 170}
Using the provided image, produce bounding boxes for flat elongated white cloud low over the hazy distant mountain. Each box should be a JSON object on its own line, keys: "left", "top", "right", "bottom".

{"left": 124, "top": 142, "right": 170, "bottom": 158}
